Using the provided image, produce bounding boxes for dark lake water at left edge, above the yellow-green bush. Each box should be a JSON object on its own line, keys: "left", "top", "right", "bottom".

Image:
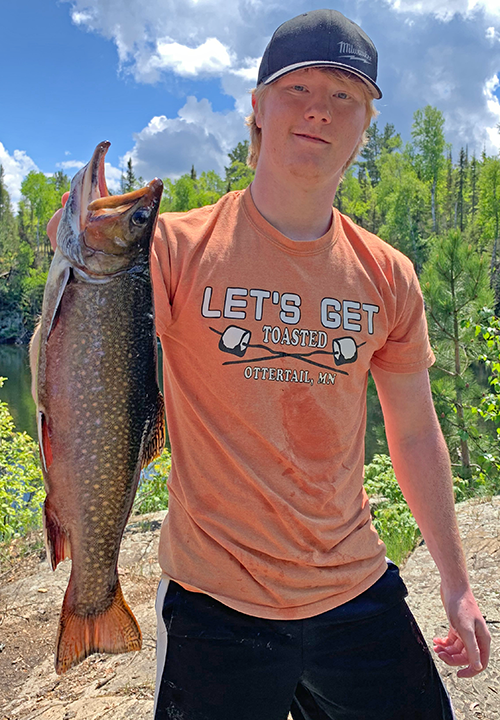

{"left": 0, "top": 345, "right": 37, "bottom": 440}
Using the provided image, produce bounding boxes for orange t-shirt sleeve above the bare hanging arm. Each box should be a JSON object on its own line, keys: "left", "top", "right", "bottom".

{"left": 371, "top": 258, "right": 435, "bottom": 373}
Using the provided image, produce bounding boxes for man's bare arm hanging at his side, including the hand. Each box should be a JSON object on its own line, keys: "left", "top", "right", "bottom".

{"left": 372, "top": 367, "right": 490, "bottom": 677}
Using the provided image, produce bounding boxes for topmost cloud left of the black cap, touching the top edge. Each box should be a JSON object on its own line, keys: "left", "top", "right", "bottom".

{"left": 63, "top": 0, "right": 269, "bottom": 82}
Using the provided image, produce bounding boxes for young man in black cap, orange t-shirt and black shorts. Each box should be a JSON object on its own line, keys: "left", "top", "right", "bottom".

{"left": 48, "top": 10, "right": 489, "bottom": 720}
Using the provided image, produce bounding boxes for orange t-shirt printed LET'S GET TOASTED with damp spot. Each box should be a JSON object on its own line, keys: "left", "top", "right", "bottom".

{"left": 152, "top": 189, "right": 433, "bottom": 619}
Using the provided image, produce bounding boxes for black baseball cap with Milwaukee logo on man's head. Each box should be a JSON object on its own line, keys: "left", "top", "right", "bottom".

{"left": 257, "top": 9, "right": 382, "bottom": 98}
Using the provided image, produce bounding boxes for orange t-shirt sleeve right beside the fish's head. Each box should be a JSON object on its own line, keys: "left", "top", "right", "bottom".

{"left": 151, "top": 216, "right": 172, "bottom": 335}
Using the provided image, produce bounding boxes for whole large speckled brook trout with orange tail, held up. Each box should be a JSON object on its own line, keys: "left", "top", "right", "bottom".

{"left": 31, "top": 142, "right": 165, "bottom": 674}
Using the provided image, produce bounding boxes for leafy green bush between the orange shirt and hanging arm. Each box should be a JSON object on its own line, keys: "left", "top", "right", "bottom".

{"left": 364, "top": 455, "right": 420, "bottom": 564}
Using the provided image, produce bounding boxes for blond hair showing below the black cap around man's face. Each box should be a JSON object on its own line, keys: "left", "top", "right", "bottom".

{"left": 245, "top": 67, "right": 378, "bottom": 173}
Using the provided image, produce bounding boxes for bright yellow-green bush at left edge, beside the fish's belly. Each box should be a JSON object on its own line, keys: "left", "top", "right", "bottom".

{"left": 0, "top": 378, "right": 45, "bottom": 541}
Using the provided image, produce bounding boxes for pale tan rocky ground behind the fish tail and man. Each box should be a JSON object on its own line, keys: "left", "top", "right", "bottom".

{"left": 0, "top": 497, "right": 500, "bottom": 720}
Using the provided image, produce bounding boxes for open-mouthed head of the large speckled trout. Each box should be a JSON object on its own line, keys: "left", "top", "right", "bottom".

{"left": 57, "top": 142, "right": 163, "bottom": 277}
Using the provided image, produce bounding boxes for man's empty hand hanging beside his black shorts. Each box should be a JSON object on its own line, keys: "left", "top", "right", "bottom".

{"left": 434, "top": 585, "right": 491, "bottom": 677}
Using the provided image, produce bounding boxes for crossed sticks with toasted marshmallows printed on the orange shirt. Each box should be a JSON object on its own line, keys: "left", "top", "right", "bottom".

{"left": 210, "top": 325, "right": 366, "bottom": 375}
